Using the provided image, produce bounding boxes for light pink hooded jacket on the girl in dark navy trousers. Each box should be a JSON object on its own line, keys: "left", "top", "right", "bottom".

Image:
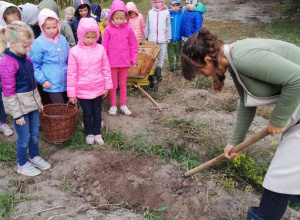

{"left": 67, "top": 18, "right": 113, "bottom": 99}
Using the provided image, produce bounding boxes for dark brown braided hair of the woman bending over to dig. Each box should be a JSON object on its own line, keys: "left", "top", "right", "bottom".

{"left": 181, "top": 27, "right": 225, "bottom": 91}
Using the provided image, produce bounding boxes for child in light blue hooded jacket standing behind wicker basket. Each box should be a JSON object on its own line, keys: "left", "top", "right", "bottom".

{"left": 30, "top": 9, "right": 70, "bottom": 103}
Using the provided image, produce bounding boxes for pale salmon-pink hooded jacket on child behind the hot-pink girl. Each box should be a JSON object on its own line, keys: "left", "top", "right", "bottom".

{"left": 126, "top": 2, "right": 145, "bottom": 41}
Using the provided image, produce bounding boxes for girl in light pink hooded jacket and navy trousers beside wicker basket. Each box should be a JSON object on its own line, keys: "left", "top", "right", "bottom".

{"left": 67, "top": 18, "right": 113, "bottom": 145}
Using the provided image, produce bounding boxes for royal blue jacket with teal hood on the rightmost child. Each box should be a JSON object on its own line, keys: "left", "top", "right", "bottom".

{"left": 181, "top": 2, "right": 206, "bottom": 37}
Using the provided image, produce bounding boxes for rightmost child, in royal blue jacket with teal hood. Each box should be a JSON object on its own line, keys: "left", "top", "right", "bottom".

{"left": 181, "top": 0, "right": 206, "bottom": 46}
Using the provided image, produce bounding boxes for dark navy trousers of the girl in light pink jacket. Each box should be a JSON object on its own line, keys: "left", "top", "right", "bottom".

{"left": 79, "top": 96, "right": 102, "bottom": 135}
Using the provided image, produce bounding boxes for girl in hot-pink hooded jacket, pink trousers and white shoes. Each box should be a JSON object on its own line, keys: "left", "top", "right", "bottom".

{"left": 102, "top": 0, "right": 138, "bottom": 115}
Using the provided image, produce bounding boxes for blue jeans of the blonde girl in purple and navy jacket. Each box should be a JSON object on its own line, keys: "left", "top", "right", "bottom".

{"left": 14, "top": 110, "right": 40, "bottom": 166}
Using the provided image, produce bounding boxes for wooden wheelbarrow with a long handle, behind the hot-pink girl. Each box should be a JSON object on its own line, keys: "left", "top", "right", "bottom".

{"left": 127, "top": 41, "right": 162, "bottom": 111}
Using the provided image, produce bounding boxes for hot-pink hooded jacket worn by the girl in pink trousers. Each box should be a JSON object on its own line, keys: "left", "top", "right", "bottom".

{"left": 102, "top": 0, "right": 138, "bottom": 68}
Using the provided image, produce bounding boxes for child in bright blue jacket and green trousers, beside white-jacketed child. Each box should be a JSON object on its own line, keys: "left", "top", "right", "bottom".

{"left": 168, "top": 0, "right": 183, "bottom": 72}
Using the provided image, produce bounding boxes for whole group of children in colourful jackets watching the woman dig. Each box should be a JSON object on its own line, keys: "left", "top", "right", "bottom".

{"left": 0, "top": 0, "right": 205, "bottom": 176}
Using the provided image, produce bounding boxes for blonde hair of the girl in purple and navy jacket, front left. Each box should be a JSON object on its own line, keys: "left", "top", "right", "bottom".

{"left": 0, "top": 21, "right": 34, "bottom": 54}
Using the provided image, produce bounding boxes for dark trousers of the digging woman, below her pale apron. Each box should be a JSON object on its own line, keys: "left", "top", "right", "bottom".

{"left": 257, "top": 189, "right": 300, "bottom": 220}
